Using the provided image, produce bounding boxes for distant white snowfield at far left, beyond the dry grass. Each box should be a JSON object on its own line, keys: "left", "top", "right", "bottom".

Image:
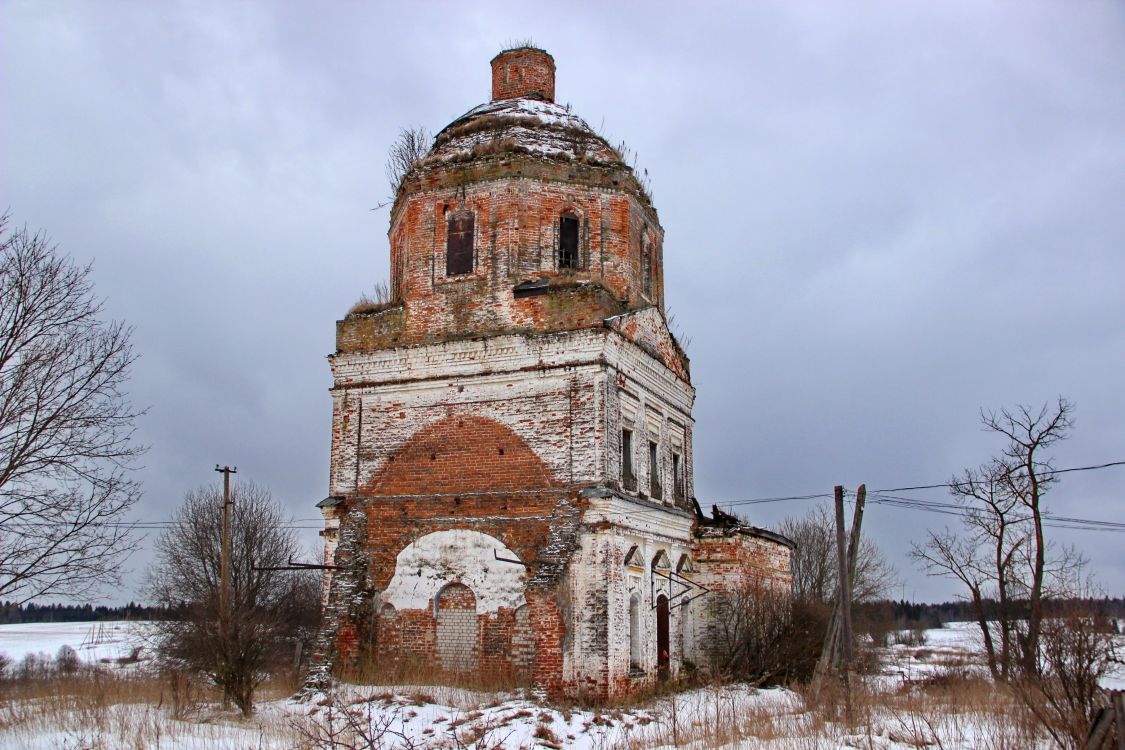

{"left": 0, "top": 621, "right": 145, "bottom": 663}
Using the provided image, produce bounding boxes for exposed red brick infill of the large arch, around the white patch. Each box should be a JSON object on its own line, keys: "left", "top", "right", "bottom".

{"left": 350, "top": 416, "right": 570, "bottom": 689}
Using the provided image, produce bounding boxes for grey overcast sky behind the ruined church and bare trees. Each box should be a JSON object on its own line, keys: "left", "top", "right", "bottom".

{"left": 0, "top": 0, "right": 1125, "bottom": 600}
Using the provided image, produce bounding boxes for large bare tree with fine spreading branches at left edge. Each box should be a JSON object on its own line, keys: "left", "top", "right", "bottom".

{"left": 0, "top": 216, "right": 144, "bottom": 602}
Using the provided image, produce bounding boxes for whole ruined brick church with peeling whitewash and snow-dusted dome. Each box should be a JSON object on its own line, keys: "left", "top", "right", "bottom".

{"left": 314, "top": 47, "right": 791, "bottom": 697}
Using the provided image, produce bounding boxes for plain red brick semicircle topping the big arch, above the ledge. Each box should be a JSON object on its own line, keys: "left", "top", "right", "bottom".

{"left": 363, "top": 415, "right": 551, "bottom": 495}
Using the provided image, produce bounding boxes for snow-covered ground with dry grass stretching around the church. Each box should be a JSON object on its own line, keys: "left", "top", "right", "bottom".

{"left": 0, "top": 623, "right": 1120, "bottom": 750}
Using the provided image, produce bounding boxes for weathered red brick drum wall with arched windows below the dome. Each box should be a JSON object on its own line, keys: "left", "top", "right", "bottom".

{"left": 378, "top": 168, "right": 664, "bottom": 351}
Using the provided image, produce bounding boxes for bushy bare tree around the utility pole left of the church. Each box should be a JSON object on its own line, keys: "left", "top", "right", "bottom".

{"left": 149, "top": 482, "right": 320, "bottom": 715}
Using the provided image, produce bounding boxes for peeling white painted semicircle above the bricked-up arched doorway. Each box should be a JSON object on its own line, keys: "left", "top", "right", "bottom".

{"left": 383, "top": 528, "right": 527, "bottom": 613}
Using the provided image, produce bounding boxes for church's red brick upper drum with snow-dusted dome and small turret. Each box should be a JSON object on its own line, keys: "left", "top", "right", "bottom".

{"left": 360, "top": 47, "right": 666, "bottom": 359}
